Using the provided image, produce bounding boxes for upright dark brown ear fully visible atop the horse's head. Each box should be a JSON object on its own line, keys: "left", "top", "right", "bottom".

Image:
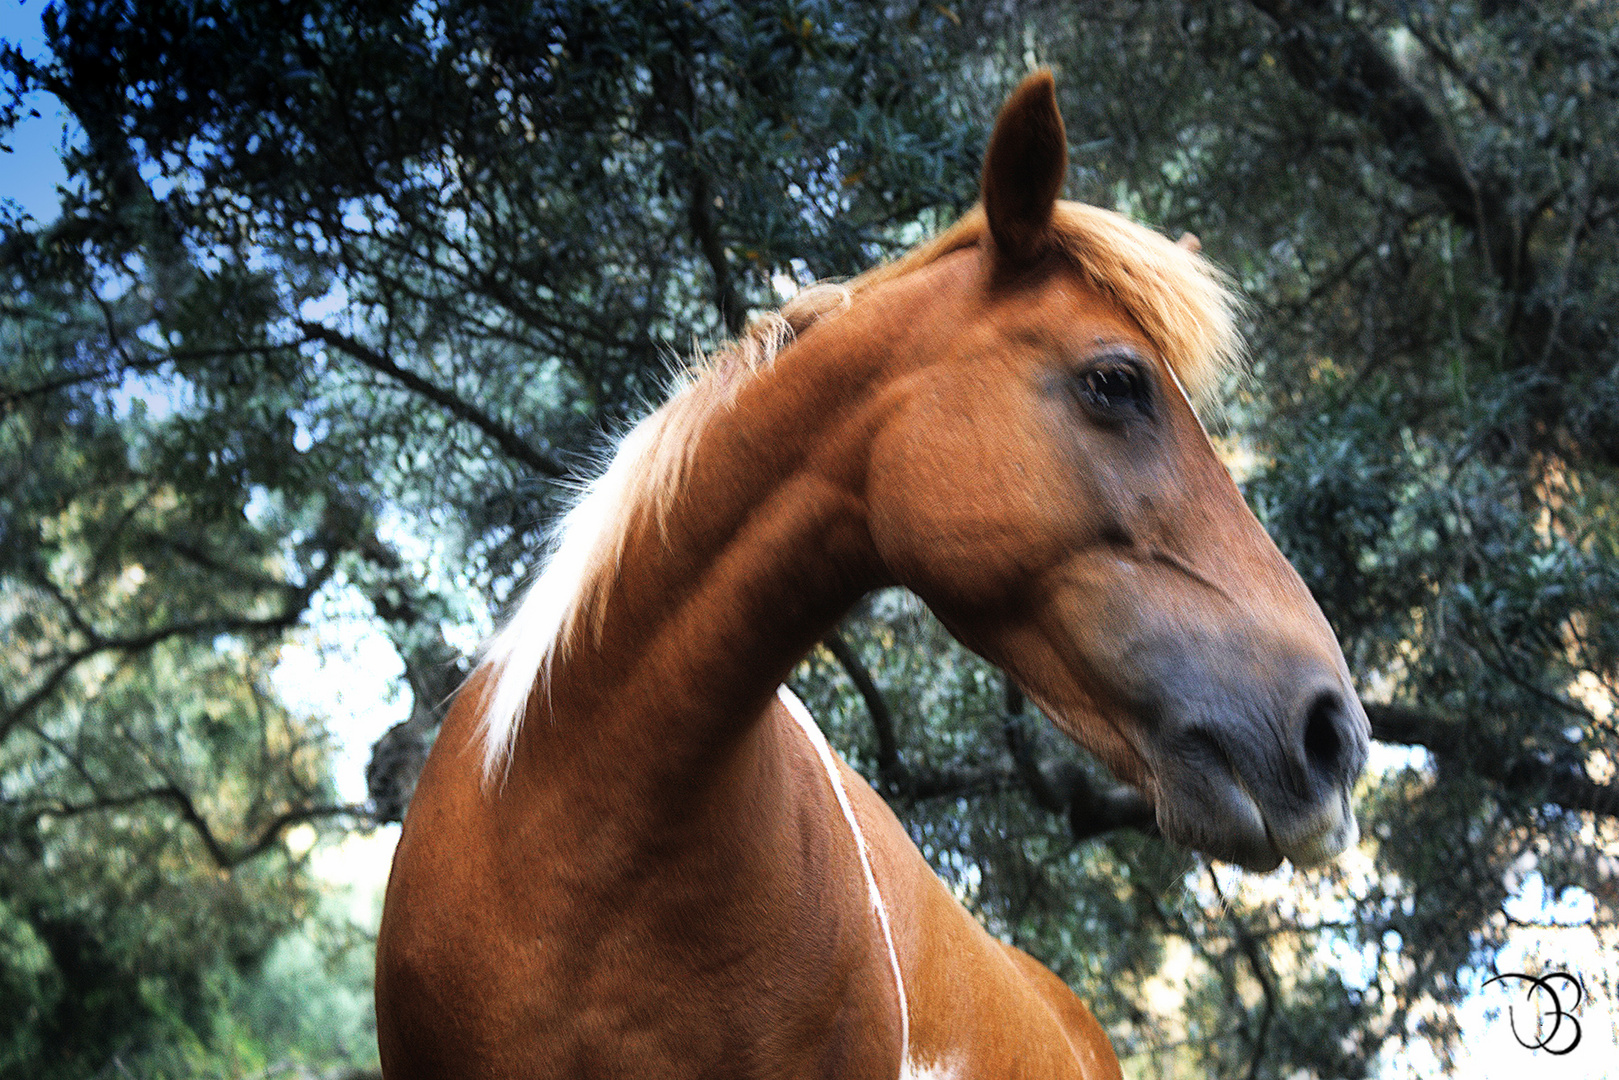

{"left": 983, "top": 68, "right": 1069, "bottom": 264}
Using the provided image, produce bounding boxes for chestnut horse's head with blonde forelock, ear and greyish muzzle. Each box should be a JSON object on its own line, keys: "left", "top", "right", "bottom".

{"left": 865, "top": 73, "right": 1370, "bottom": 870}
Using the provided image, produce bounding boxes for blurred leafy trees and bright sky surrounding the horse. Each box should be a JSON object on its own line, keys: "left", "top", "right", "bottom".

{"left": 0, "top": 0, "right": 1619, "bottom": 1080}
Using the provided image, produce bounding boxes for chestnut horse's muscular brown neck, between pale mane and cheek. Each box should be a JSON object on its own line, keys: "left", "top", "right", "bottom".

{"left": 513, "top": 307, "right": 886, "bottom": 795}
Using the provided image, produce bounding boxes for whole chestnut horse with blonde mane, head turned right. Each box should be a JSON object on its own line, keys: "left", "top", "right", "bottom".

{"left": 377, "top": 73, "right": 1368, "bottom": 1080}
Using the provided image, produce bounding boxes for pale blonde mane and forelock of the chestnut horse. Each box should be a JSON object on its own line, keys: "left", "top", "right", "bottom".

{"left": 479, "top": 202, "right": 1242, "bottom": 782}
